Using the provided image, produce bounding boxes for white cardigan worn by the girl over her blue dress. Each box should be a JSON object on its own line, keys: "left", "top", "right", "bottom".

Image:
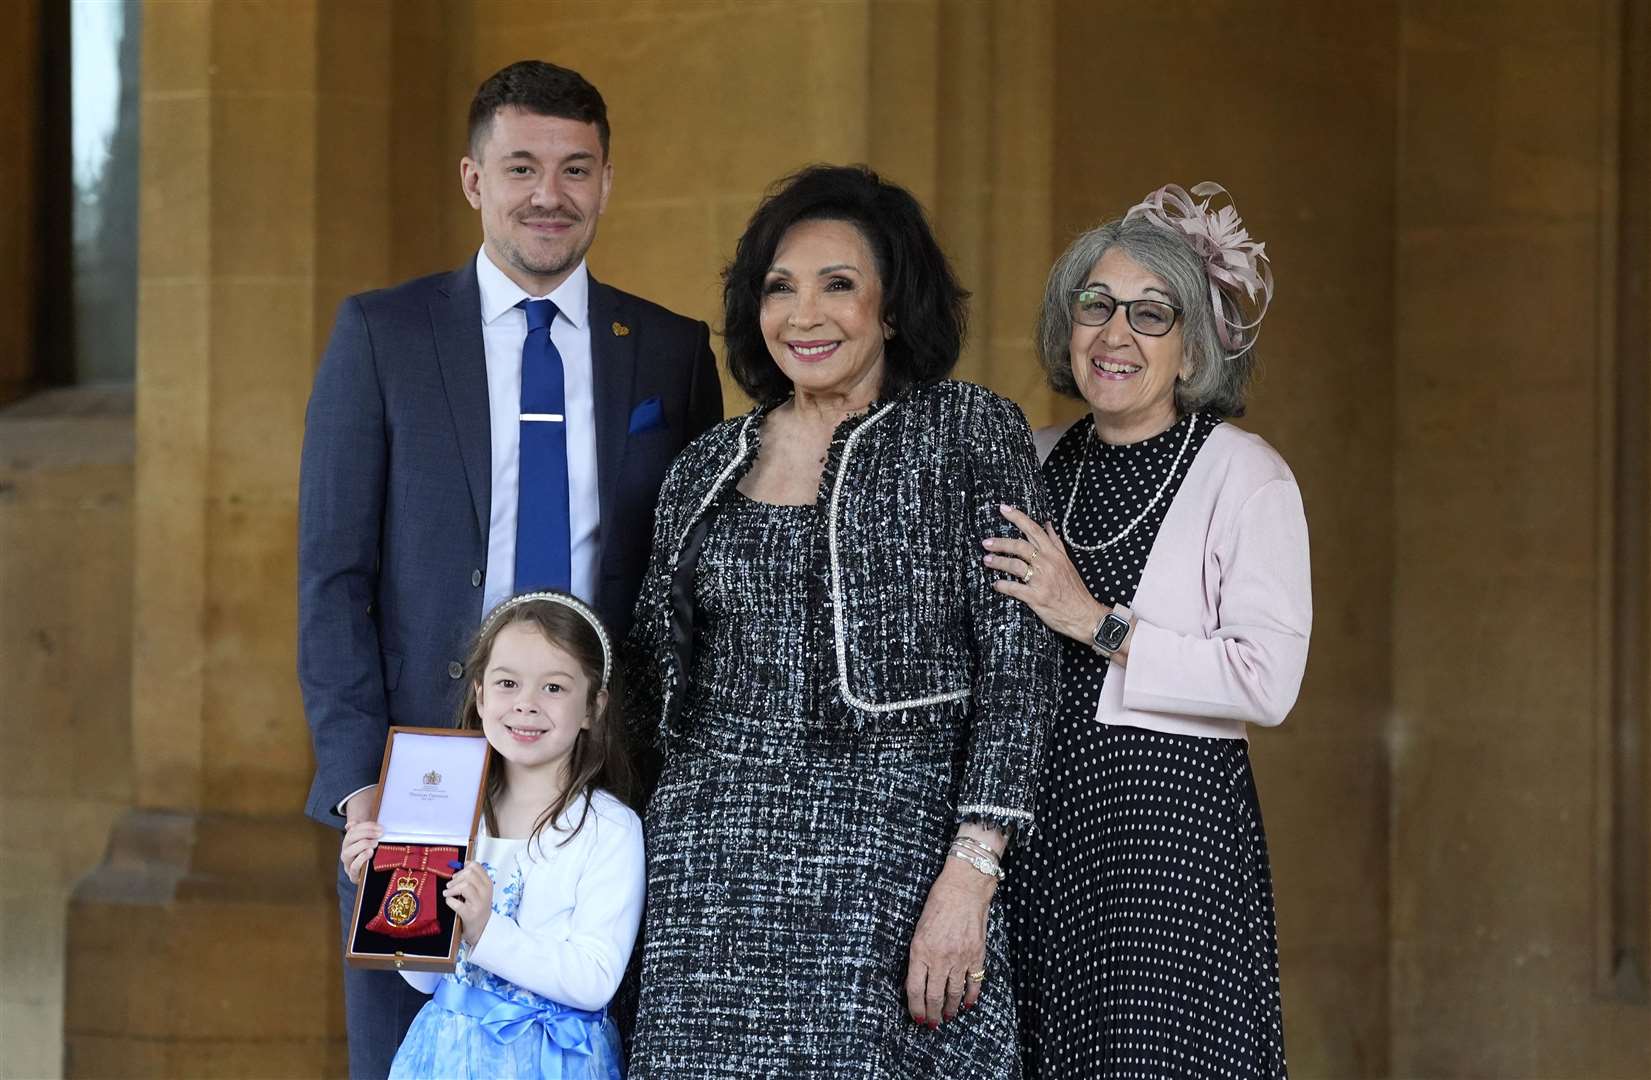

{"left": 401, "top": 791, "right": 647, "bottom": 1012}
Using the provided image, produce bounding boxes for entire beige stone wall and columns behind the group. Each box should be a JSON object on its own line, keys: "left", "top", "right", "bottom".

{"left": 0, "top": 0, "right": 1651, "bottom": 1080}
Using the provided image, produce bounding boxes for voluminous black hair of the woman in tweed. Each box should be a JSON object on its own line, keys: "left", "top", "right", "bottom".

{"left": 723, "top": 165, "right": 969, "bottom": 405}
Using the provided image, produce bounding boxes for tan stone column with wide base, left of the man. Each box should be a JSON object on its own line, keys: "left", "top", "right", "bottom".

{"left": 64, "top": 0, "right": 391, "bottom": 1077}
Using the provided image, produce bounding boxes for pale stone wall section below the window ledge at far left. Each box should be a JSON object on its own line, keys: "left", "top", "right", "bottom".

{"left": 0, "top": 390, "right": 132, "bottom": 1080}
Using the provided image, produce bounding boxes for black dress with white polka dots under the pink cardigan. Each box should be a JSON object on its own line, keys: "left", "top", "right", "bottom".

{"left": 1005, "top": 414, "right": 1284, "bottom": 1080}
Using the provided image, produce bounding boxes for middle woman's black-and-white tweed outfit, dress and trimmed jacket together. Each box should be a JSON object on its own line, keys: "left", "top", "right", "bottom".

{"left": 624, "top": 381, "right": 1058, "bottom": 1080}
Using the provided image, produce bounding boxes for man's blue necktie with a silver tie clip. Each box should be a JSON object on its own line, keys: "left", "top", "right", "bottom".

{"left": 515, "top": 301, "right": 573, "bottom": 593}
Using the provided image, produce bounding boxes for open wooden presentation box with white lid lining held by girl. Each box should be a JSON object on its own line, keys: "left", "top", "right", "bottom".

{"left": 345, "top": 727, "right": 489, "bottom": 971}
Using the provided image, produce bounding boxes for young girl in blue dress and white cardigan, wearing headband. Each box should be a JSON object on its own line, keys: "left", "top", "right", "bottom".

{"left": 342, "top": 593, "right": 644, "bottom": 1080}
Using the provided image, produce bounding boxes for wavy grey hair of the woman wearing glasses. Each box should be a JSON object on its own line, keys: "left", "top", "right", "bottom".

{"left": 1037, "top": 216, "right": 1255, "bottom": 418}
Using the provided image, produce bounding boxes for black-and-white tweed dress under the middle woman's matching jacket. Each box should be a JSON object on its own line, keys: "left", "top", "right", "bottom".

{"left": 631, "top": 492, "right": 1019, "bottom": 1080}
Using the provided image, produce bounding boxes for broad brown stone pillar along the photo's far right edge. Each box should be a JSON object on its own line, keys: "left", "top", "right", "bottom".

{"left": 1392, "top": 0, "right": 1651, "bottom": 1077}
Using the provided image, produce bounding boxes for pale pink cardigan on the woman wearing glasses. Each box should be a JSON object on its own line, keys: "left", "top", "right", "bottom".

{"left": 1037, "top": 423, "right": 1313, "bottom": 738}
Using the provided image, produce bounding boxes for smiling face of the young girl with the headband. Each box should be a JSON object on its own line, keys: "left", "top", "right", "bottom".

{"left": 475, "top": 623, "right": 608, "bottom": 778}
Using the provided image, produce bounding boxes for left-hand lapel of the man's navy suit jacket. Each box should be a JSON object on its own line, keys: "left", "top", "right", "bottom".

{"left": 429, "top": 263, "right": 494, "bottom": 545}
